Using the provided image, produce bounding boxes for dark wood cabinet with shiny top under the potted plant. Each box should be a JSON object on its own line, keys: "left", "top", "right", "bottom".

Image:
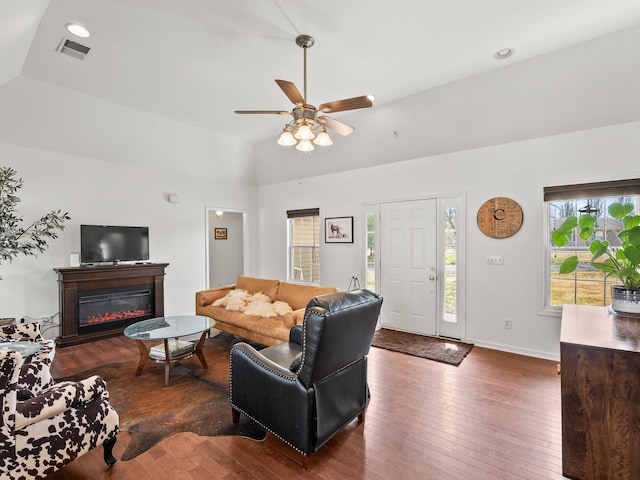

{"left": 560, "top": 305, "right": 640, "bottom": 480}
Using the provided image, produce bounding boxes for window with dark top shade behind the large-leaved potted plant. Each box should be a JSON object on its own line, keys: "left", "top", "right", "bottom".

{"left": 544, "top": 179, "right": 640, "bottom": 310}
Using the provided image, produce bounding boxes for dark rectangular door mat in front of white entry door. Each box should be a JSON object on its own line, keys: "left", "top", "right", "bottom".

{"left": 371, "top": 328, "right": 473, "bottom": 367}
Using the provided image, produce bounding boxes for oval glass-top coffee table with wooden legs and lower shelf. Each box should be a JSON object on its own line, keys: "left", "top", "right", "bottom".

{"left": 124, "top": 315, "right": 216, "bottom": 386}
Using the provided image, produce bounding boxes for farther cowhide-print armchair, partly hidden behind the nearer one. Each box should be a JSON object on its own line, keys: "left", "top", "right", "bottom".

{"left": 0, "top": 323, "right": 56, "bottom": 394}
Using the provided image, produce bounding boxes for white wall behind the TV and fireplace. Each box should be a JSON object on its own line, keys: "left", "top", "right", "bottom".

{"left": 0, "top": 143, "right": 257, "bottom": 337}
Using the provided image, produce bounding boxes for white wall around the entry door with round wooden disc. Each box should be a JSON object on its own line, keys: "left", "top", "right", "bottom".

{"left": 258, "top": 122, "right": 640, "bottom": 359}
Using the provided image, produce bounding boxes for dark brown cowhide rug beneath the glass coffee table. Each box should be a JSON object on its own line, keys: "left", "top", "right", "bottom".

{"left": 58, "top": 333, "right": 266, "bottom": 460}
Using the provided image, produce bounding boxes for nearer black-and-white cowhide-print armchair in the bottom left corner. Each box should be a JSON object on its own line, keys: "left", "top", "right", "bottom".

{"left": 0, "top": 351, "right": 119, "bottom": 480}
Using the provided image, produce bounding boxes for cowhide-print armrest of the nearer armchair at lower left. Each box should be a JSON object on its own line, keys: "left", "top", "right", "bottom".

{"left": 15, "top": 375, "right": 109, "bottom": 430}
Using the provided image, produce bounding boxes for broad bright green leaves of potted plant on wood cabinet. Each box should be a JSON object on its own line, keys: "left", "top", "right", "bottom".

{"left": 552, "top": 203, "right": 640, "bottom": 290}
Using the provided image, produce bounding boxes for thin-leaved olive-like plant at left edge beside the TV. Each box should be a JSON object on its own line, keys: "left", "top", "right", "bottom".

{"left": 0, "top": 167, "right": 71, "bottom": 278}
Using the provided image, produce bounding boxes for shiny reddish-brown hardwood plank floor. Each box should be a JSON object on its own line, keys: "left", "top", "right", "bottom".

{"left": 50, "top": 337, "right": 563, "bottom": 480}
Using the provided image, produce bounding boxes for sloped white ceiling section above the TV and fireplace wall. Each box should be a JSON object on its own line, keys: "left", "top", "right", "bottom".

{"left": 0, "top": 76, "right": 256, "bottom": 189}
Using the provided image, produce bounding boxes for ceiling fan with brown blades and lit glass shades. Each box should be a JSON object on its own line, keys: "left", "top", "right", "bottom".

{"left": 235, "top": 35, "right": 373, "bottom": 152}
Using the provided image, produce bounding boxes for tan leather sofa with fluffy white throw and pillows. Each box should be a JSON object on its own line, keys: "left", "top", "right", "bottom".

{"left": 196, "top": 275, "right": 338, "bottom": 346}
